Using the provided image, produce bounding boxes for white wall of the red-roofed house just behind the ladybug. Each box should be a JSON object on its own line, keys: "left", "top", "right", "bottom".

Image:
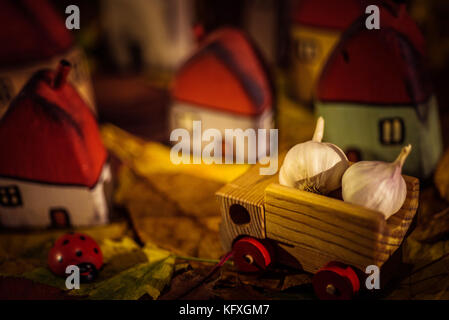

{"left": 0, "top": 164, "right": 111, "bottom": 227}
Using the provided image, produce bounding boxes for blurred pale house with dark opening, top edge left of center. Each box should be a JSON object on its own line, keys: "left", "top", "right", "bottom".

{"left": 101, "top": 0, "right": 194, "bottom": 71}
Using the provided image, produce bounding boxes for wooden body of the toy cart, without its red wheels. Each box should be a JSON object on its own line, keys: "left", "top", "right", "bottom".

{"left": 217, "top": 161, "right": 419, "bottom": 272}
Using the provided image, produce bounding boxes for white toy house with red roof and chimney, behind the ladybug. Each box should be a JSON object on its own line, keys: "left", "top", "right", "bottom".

{"left": 0, "top": 63, "right": 111, "bottom": 228}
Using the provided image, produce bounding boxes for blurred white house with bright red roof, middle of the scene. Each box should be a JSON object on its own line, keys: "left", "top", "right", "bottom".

{"left": 170, "top": 28, "right": 275, "bottom": 157}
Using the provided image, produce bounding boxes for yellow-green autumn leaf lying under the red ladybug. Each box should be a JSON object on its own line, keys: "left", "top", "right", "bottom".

{"left": 14, "top": 237, "right": 175, "bottom": 300}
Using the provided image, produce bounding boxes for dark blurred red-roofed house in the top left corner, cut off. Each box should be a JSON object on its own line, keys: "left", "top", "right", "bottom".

{"left": 0, "top": 0, "right": 95, "bottom": 118}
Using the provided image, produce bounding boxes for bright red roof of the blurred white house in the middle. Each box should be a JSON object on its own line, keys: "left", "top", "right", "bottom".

{"left": 173, "top": 28, "right": 273, "bottom": 115}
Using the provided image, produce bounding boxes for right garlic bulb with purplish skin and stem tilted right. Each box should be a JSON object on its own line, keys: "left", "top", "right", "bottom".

{"left": 342, "top": 145, "right": 412, "bottom": 219}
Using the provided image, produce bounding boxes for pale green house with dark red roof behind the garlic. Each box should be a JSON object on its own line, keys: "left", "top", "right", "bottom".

{"left": 316, "top": 7, "right": 442, "bottom": 177}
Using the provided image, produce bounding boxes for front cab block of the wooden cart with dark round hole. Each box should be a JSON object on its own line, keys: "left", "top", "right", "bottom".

{"left": 216, "top": 165, "right": 277, "bottom": 251}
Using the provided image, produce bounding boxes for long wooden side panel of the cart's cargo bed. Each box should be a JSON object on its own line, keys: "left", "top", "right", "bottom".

{"left": 265, "top": 184, "right": 389, "bottom": 272}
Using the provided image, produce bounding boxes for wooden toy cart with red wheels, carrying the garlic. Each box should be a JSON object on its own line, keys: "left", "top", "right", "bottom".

{"left": 216, "top": 165, "right": 419, "bottom": 299}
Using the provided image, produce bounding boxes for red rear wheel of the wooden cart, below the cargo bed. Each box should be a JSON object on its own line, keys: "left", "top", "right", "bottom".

{"left": 312, "top": 262, "right": 360, "bottom": 300}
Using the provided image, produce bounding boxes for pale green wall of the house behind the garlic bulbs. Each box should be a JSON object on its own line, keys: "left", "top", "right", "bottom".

{"left": 316, "top": 98, "right": 442, "bottom": 178}
